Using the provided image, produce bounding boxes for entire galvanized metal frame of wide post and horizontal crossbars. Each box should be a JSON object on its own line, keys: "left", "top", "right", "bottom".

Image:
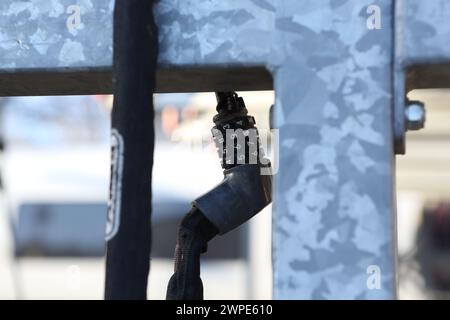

{"left": 0, "top": 0, "right": 450, "bottom": 299}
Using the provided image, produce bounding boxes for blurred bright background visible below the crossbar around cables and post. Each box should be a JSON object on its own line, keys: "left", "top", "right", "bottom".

{"left": 0, "top": 90, "right": 450, "bottom": 299}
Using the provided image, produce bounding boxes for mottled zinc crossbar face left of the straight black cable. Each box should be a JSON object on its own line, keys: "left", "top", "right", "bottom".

{"left": 0, "top": 0, "right": 114, "bottom": 71}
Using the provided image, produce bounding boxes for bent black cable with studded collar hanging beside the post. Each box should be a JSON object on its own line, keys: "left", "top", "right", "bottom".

{"left": 167, "top": 92, "right": 272, "bottom": 300}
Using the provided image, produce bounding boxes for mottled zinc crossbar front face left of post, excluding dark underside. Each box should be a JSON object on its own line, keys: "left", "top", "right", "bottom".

{"left": 0, "top": 0, "right": 274, "bottom": 71}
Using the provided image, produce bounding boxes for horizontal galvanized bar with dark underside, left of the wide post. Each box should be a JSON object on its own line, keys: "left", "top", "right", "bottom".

{"left": 0, "top": 0, "right": 274, "bottom": 96}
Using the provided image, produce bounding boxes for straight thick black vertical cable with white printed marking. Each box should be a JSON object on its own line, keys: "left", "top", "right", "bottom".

{"left": 105, "top": 0, "right": 158, "bottom": 299}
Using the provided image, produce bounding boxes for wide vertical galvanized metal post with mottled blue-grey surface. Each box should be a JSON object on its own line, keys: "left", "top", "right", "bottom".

{"left": 271, "top": 0, "right": 396, "bottom": 299}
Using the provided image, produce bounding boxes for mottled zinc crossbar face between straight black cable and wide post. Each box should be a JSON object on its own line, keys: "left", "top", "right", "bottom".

{"left": 156, "top": 0, "right": 275, "bottom": 66}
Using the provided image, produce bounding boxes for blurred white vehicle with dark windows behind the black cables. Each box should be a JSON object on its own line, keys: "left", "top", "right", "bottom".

{"left": 0, "top": 97, "right": 270, "bottom": 299}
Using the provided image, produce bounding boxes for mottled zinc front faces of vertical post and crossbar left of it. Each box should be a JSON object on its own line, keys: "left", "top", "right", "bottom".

{"left": 0, "top": 0, "right": 395, "bottom": 299}
